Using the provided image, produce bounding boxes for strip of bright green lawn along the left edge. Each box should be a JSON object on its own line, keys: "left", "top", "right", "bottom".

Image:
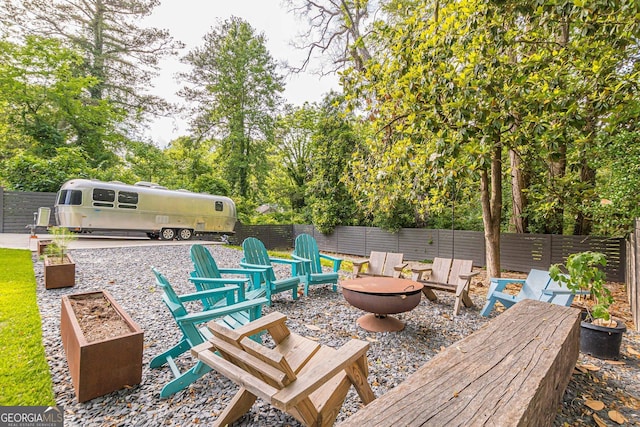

{"left": 0, "top": 249, "right": 55, "bottom": 406}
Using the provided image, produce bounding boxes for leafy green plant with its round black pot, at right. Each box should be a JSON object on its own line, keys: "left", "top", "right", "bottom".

{"left": 549, "top": 251, "right": 627, "bottom": 359}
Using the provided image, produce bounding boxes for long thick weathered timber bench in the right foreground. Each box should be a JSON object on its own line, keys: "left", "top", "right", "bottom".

{"left": 341, "top": 300, "right": 580, "bottom": 427}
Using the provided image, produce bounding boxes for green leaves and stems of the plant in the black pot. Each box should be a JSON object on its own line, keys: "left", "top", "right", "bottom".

{"left": 549, "top": 251, "right": 613, "bottom": 321}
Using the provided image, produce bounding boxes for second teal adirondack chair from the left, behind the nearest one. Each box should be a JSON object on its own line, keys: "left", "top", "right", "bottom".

{"left": 189, "top": 244, "right": 266, "bottom": 308}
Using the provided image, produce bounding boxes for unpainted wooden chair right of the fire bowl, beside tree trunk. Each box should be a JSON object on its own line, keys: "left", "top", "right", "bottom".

{"left": 411, "top": 258, "right": 480, "bottom": 316}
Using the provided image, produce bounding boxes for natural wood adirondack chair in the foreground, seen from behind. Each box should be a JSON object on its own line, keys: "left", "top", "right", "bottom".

{"left": 191, "top": 312, "right": 375, "bottom": 426}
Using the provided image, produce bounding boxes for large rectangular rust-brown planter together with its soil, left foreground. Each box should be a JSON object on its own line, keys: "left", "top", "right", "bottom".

{"left": 60, "top": 290, "right": 144, "bottom": 402}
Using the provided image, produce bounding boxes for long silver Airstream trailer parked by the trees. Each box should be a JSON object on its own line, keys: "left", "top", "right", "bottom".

{"left": 55, "top": 179, "right": 236, "bottom": 240}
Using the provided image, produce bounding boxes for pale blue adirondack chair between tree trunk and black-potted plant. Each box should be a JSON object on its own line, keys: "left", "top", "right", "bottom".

{"left": 480, "top": 269, "right": 584, "bottom": 316}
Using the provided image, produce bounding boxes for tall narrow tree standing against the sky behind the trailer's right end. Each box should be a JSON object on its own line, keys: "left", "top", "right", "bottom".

{"left": 180, "top": 17, "right": 283, "bottom": 198}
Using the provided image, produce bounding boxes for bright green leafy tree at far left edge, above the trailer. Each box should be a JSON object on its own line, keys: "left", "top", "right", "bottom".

{"left": 0, "top": 36, "right": 121, "bottom": 167}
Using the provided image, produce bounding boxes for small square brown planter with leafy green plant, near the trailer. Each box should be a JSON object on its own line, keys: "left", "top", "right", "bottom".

{"left": 44, "top": 227, "right": 76, "bottom": 289}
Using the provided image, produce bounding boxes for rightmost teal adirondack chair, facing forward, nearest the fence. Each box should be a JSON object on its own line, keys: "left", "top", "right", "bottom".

{"left": 292, "top": 234, "right": 342, "bottom": 296}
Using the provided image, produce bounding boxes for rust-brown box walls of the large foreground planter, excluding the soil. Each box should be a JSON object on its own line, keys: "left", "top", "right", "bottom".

{"left": 60, "top": 291, "right": 143, "bottom": 402}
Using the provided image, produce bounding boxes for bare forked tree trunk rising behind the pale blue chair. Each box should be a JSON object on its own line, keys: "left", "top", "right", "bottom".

{"left": 480, "top": 143, "right": 502, "bottom": 277}
